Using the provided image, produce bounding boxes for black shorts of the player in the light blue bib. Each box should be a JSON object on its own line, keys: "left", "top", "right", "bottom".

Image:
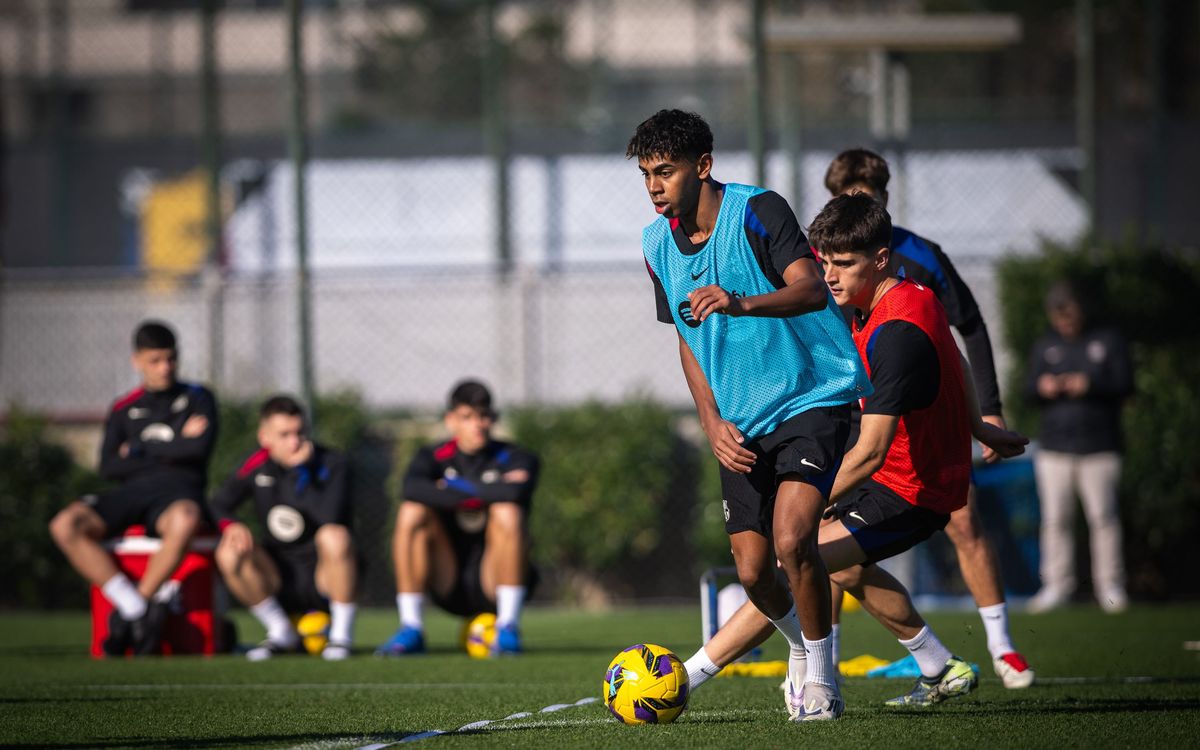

{"left": 721, "top": 404, "right": 850, "bottom": 538}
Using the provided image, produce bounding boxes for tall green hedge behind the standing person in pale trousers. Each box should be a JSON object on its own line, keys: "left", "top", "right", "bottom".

{"left": 998, "top": 236, "right": 1200, "bottom": 596}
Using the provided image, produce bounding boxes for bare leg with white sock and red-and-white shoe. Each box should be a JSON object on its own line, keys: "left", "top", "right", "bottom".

{"left": 946, "top": 485, "right": 1033, "bottom": 688}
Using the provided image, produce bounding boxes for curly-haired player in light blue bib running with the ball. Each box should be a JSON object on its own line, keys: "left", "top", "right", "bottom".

{"left": 625, "top": 109, "right": 870, "bottom": 720}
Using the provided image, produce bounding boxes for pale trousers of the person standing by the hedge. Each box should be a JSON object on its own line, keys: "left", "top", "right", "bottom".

{"left": 1033, "top": 450, "right": 1124, "bottom": 596}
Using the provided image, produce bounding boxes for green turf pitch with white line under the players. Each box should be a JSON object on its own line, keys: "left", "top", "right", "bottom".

{"left": 0, "top": 605, "right": 1200, "bottom": 749}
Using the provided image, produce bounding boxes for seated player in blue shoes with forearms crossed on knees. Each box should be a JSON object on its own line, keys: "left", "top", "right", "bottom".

{"left": 377, "top": 380, "right": 538, "bottom": 656}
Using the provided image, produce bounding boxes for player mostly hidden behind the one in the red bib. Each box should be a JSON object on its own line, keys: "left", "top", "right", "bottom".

{"left": 826, "top": 149, "right": 1033, "bottom": 688}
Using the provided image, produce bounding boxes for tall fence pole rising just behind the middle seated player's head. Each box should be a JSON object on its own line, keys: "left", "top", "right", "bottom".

{"left": 287, "top": 0, "right": 316, "bottom": 410}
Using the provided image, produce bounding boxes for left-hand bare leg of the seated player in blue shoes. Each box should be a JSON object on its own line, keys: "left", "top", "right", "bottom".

{"left": 376, "top": 500, "right": 458, "bottom": 656}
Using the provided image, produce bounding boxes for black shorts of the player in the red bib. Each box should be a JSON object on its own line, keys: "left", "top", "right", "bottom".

{"left": 826, "top": 479, "right": 950, "bottom": 563}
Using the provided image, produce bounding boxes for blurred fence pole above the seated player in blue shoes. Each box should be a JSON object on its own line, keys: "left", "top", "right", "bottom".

{"left": 482, "top": 0, "right": 512, "bottom": 276}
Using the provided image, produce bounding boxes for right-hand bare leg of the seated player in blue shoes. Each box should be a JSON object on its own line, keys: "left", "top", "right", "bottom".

{"left": 480, "top": 503, "right": 529, "bottom": 654}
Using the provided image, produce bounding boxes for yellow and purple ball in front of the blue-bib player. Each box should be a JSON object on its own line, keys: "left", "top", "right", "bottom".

{"left": 604, "top": 643, "right": 688, "bottom": 724}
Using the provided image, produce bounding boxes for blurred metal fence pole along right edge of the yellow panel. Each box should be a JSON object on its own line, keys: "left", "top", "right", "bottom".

{"left": 200, "top": 0, "right": 224, "bottom": 389}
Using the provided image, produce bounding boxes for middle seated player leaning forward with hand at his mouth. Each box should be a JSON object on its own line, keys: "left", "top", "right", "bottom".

{"left": 210, "top": 396, "right": 358, "bottom": 661}
